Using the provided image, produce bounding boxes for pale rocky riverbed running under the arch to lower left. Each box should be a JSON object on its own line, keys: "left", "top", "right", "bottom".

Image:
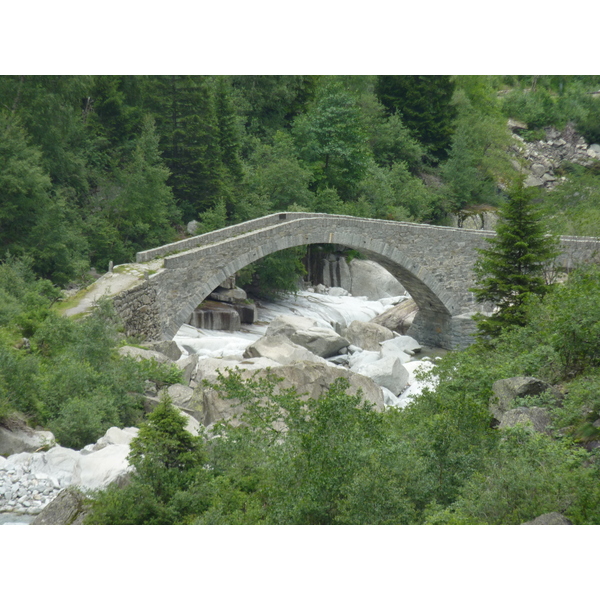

{"left": 0, "top": 264, "right": 440, "bottom": 524}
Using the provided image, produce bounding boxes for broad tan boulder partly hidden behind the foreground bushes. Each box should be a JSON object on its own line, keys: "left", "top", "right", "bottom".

{"left": 194, "top": 361, "right": 384, "bottom": 426}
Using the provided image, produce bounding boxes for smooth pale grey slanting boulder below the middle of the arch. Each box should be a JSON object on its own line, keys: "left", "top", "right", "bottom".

{"left": 265, "top": 316, "right": 348, "bottom": 358}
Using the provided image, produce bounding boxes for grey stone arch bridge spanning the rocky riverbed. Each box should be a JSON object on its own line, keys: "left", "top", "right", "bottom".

{"left": 114, "top": 213, "right": 600, "bottom": 349}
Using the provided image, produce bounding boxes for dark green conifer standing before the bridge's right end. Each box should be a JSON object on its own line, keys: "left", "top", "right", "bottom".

{"left": 471, "top": 184, "right": 558, "bottom": 337}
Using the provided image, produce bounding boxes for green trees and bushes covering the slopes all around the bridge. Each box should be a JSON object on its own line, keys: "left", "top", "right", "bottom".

{"left": 0, "top": 76, "right": 600, "bottom": 524}
